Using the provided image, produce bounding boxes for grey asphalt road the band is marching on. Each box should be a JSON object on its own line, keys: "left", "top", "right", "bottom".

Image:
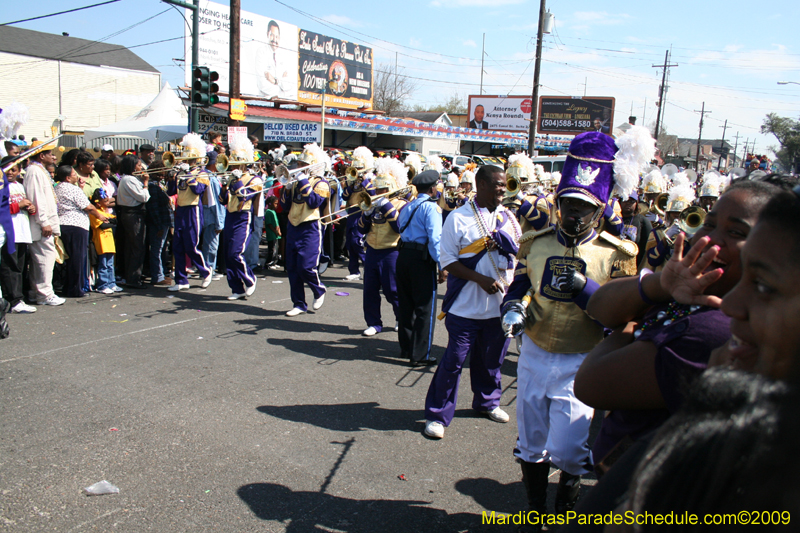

{"left": 0, "top": 262, "right": 592, "bottom": 533}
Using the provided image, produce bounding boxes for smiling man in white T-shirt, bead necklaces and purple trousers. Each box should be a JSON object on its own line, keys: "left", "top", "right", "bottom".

{"left": 424, "top": 165, "right": 520, "bottom": 439}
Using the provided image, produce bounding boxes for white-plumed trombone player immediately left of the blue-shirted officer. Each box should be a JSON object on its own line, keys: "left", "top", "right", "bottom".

{"left": 358, "top": 157, "right": 408, "bottom": 337}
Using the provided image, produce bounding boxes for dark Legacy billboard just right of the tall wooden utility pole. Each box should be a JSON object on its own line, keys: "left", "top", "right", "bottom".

{"left": 536, "top": 96, "right": 614, "bottom": 135}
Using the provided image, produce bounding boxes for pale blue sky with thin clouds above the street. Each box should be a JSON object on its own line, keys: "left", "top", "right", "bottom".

{"left": 3, "top": 0, "right": 800, "bottom": 157}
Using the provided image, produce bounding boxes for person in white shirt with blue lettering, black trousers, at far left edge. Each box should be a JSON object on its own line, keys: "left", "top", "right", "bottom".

{"left": 0, "top": 156, "right": 36, "bottom": 313}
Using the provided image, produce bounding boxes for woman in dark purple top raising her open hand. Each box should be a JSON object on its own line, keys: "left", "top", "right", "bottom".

{"left": 575, "top": 182, "right": 778, "bottom": 471}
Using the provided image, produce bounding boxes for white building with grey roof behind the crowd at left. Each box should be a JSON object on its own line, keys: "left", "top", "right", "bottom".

{"left": 0, "top": 26, "right": 161, "bottom": 140}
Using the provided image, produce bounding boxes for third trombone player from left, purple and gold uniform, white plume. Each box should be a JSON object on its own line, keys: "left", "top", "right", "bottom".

{"left": 280, "top": 143, "right": 331, "bottom": 316}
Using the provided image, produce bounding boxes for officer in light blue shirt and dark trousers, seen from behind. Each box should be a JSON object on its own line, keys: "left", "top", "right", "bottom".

{"left": 397, "top": 170, "right": 442, "bottom": 366}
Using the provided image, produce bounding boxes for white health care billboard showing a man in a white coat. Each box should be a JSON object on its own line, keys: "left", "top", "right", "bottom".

{"left": 184, "top": 1, "right": 298, "bottom": 100}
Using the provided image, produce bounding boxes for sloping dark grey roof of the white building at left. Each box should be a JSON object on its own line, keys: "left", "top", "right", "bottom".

{"left": 0, "top": 26, "right": 158, "bottom": 73}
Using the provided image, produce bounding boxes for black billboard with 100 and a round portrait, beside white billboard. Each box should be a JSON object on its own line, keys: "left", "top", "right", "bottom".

{"left": 297, "top": 30, "right": 372, "bottom": 108}
